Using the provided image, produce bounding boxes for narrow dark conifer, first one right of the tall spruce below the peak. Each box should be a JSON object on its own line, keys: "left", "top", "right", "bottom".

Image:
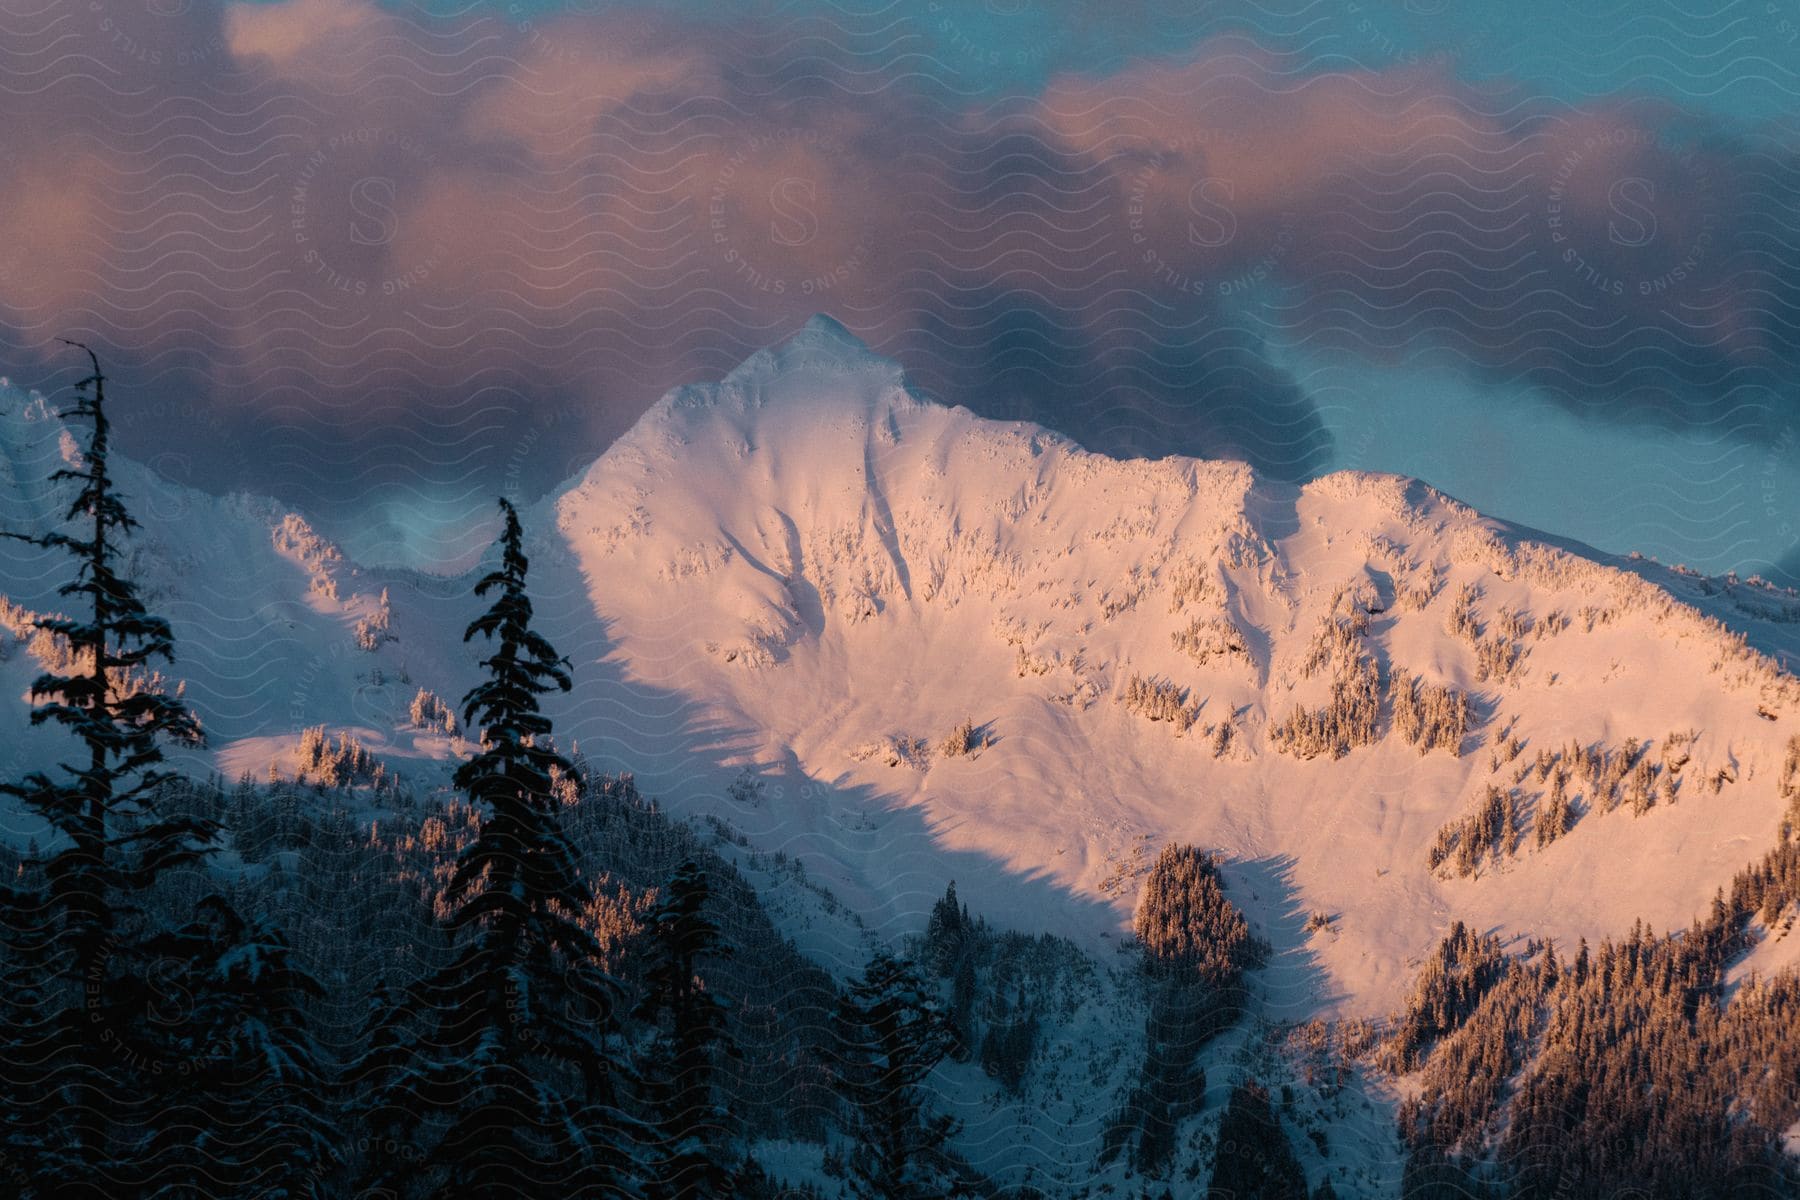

{"left": 637, "top": 858, "right": 738, "bottom": 1200}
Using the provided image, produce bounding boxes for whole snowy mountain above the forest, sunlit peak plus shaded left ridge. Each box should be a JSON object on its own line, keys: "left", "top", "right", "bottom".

{"left": 0, "top": 317, "right": 1800, "bottom": 1194}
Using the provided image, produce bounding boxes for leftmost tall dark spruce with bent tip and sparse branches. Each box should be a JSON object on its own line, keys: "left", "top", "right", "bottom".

{"left": 0, "top": 342, "right": 212, "bottom": 1196}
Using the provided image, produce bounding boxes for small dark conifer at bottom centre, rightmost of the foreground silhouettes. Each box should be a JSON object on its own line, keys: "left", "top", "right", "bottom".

{"left": 839, "top": 952, "right": 961, "bottom": 1200}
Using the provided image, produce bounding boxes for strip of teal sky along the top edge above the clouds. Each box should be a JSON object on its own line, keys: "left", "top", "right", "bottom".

{"left": 468, "top": 0, "right": 1800, "bottom": 124}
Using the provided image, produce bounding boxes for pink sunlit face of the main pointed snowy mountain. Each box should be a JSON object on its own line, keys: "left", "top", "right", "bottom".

{"left": 554, "top": 318, "right": 1800, "bottom": 1011}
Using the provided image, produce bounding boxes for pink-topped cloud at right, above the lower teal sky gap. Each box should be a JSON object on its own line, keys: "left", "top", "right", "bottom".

{"left": 1042, "top": 45, "right": 1800, "bottom": 435}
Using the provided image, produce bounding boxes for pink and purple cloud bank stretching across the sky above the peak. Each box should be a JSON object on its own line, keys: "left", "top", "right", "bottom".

{"left": 0, "top": 0, "right": 1800, "bottom": 550}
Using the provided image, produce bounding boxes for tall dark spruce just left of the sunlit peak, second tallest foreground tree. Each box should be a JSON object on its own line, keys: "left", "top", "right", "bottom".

{"left": 385, "top": 500, "right": 637, "bottom": 1196}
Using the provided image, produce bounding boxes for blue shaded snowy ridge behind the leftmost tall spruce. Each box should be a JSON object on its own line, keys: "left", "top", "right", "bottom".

{"left": 0, "top": 379, "right": 466, "bottom": 802}
